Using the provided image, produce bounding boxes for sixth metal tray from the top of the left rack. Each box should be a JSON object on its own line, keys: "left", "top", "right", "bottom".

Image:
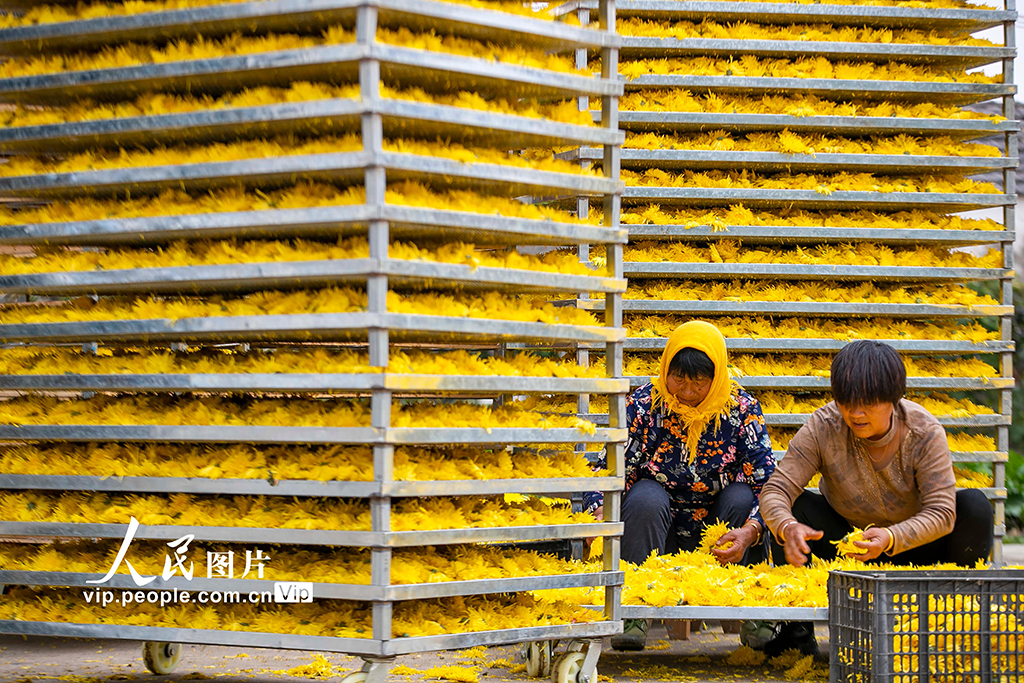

{"left": 0, "top": 258, "right": 626, "bottom": 295}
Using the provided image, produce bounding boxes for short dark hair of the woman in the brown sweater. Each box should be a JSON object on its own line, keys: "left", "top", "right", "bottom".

{"left": 831, "top": 339, "right": 906, "bottom": 405}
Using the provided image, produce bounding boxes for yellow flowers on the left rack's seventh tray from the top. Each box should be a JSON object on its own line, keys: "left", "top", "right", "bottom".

{"left": 0, "top": 287, "right": 595, "bottom": 325}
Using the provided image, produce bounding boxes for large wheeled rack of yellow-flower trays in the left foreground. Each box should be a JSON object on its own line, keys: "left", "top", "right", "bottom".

{"left": 0, "top": 0, "right": 628, "bottom": 683}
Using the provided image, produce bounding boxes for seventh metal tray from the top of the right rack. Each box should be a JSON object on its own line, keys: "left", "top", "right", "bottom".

{"left": 622, "top": 225, "right": 1014, "bottom": 248}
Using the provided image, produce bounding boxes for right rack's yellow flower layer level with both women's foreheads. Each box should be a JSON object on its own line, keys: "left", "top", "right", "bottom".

{"left": 610, "top": 353, "right": 996, "bottom": 383}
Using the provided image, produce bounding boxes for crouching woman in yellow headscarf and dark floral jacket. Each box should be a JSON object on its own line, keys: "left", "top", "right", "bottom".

{"left": 585, "top": 321, "right": 775, "bottom": 649}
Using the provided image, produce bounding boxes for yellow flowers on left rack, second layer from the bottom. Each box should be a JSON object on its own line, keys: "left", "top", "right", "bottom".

{"left": 0, "top": 540, "right": 599, "bottom": 585}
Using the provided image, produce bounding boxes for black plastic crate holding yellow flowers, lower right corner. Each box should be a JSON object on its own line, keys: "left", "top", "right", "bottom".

{"left": 828, "top": 569, "right": 1024, "bottom": 683}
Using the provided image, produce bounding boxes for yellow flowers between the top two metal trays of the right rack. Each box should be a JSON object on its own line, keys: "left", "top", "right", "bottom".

{"left": 615, "top": 18, "right": 994, "bottom": 47}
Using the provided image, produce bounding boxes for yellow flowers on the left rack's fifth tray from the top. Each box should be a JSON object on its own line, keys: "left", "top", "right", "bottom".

{"left": 0, "top": 180, "right": 599, "bottom": 225}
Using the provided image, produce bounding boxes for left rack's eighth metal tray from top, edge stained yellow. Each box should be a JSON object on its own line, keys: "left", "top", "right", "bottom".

{"left": 0, "top": 373, "right": 629, "bottom": 395}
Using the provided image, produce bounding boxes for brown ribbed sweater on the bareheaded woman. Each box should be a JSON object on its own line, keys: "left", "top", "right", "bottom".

{"left": 761, "top": 399, "right": 956, "bottom": 555}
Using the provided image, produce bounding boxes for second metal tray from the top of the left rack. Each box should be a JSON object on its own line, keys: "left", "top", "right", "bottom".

{"left": 0, "top": 43, "right": 623, "bottom": 104}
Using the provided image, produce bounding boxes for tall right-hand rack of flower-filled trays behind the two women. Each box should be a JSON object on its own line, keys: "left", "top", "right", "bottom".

{"left": 562, "top": 0, "right": 1019, "bottom": 618}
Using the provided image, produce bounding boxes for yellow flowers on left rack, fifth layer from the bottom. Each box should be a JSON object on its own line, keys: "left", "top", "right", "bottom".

{"left": 0, "top": 395, "right": 594, "bottom": 433}
